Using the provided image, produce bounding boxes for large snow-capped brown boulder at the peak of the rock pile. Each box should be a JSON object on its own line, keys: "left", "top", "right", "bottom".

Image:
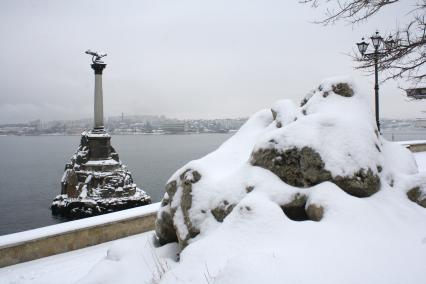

{"left": 250, "top": 81, "right": 382, "bottom": 197}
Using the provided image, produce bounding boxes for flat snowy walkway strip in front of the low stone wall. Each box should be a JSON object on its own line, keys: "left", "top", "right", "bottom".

{"left": 0, "top": 231, "right": 176, "bottom": 284}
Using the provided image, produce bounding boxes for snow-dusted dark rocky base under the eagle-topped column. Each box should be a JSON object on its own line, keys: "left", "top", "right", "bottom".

{"left": 51, "top": 130, "right": 151, "bottom": 219}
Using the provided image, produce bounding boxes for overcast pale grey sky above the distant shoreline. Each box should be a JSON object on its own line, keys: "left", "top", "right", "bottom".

{"left": 0, "top": 0, "right": 426, "bottom": 123}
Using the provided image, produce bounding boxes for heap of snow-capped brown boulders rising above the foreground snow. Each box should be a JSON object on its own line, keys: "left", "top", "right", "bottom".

{"left": 156, "top": 78, "right": 423, "bottom": 248}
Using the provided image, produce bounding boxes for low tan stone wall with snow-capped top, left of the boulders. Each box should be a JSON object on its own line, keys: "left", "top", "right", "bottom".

{"left": 0, "top": 203, "right": 160, "bottom": 267}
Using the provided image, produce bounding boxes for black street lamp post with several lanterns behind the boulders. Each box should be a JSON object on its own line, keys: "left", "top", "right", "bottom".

{"left": 356, "top": 32, "right": 396, "bottom": 132}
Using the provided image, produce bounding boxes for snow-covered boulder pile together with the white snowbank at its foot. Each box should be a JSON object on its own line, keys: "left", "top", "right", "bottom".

{"left": 82, "top": 78, "right": 426, "bottom": 284}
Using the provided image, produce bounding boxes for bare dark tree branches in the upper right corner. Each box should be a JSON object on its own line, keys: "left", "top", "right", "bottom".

{"left": 299, "top": 0, "right": 426, "bottom": 83}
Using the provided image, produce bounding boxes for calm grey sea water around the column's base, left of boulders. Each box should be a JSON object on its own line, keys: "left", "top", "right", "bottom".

{"left": 0, "top": 134, "right": 231, "bottom": 235}
